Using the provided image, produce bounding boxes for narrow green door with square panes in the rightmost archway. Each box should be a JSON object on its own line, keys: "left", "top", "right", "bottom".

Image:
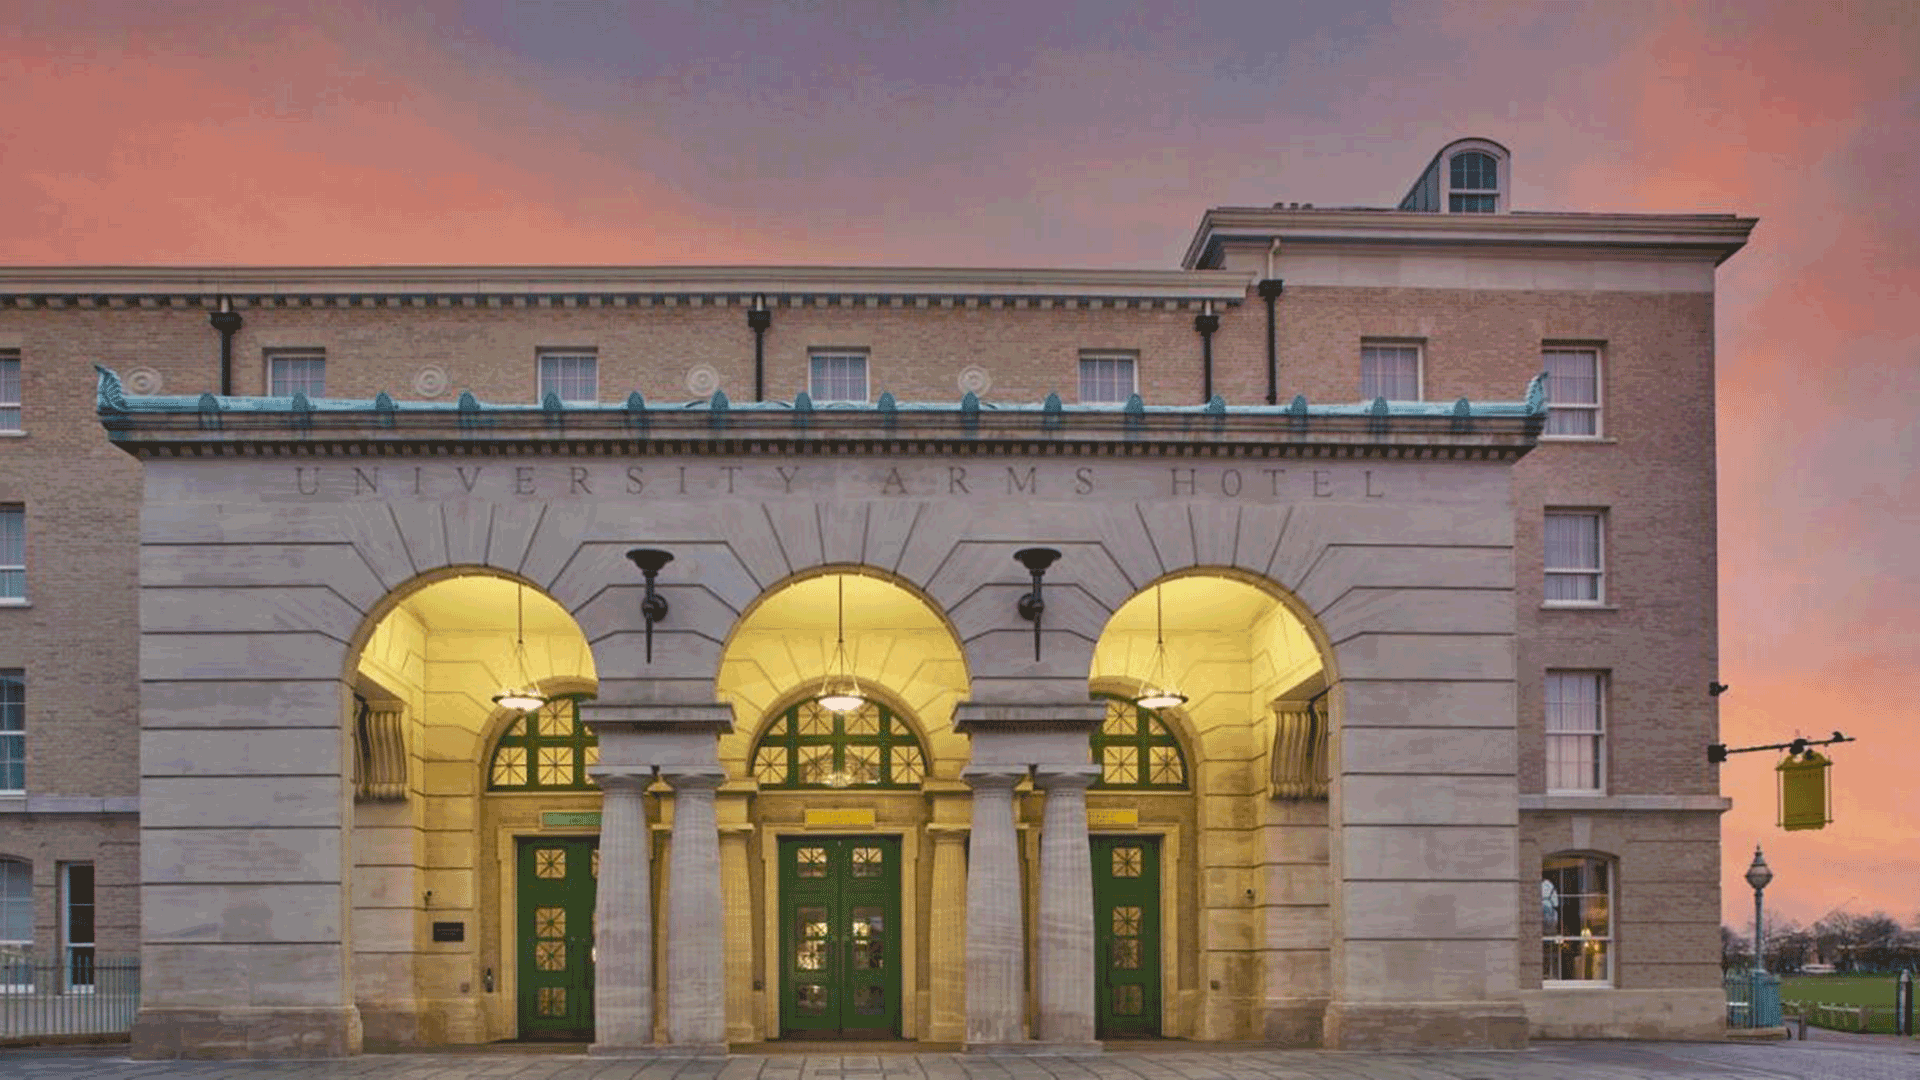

{"left": 1092, "top": 836, "right": 1160, "bottom": 1038}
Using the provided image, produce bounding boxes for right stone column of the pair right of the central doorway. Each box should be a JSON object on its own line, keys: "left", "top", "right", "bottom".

{"left": 1035, "top": 765, "right": 1100, "bottom": 1049}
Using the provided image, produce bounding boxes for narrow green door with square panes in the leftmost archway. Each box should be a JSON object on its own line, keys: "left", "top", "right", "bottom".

{"left": 518, "top": 836, "right": 599, "bottom": 1040}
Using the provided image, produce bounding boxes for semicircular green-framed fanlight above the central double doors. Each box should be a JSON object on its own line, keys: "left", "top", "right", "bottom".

{"left": 753, "top": 701, "right": 927, "bottom": 788}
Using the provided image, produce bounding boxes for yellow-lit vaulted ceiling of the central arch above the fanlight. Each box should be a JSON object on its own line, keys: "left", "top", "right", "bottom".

{"left": 716, "top": 567, "right": 968, "bottom": 778}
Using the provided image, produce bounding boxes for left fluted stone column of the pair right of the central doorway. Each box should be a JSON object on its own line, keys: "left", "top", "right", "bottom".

{"left": 964, "top": 767, "right": 1027, "bottom": 1049}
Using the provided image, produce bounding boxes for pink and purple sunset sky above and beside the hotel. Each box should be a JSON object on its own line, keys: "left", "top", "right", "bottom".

{"left": 0, "top": 0, "right": 1920, "bottom": 926}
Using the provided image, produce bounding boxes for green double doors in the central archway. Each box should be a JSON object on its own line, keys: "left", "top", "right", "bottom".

{"left": 780, "top": 836, "right": 902, "bottom": 1038}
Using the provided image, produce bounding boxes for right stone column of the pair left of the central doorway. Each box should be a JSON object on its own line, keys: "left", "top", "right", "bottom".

{"left": 662, "top": 769, "right": 726, "bottom": 1055}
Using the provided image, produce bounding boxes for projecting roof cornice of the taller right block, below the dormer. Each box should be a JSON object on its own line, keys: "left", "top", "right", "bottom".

{"left": 1183, "top": 206, "right": 1757, "bottom": 273}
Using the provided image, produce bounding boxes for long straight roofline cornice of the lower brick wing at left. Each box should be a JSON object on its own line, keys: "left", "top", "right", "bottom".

{"left": 0, "top": 267, "right": 1250, "bottom": 311}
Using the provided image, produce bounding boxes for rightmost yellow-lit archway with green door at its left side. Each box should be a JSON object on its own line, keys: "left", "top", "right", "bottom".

{"left": 1087, "top": 569, "right": 1334, "bottom": 1042}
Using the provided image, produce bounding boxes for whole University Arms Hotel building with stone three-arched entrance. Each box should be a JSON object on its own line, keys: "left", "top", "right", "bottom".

{"left": 0, "top": 140, "right": 1753, "bottom": 1055}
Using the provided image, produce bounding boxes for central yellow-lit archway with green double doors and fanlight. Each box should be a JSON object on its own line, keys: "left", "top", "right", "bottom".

{"left": 718, "top": 565, "right": 968, "bottom": 1040}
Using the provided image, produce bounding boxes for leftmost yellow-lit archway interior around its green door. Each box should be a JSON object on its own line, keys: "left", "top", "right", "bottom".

{"left": 349, "top": 567, "right": 599, "bottom": 1043}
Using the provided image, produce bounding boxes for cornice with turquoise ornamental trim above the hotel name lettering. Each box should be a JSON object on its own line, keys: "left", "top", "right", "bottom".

{"left": 98, "top": 369, "right": 1546, "bottom": 461}
